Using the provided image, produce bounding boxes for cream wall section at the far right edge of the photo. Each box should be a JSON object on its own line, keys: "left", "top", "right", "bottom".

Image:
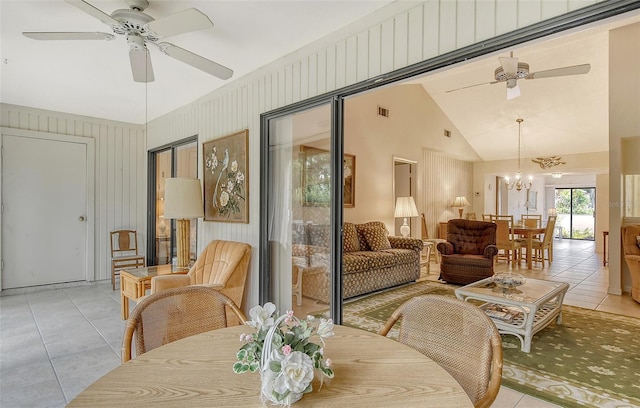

{"left": 609, "top": 23, "right": 640, "bottom": 294}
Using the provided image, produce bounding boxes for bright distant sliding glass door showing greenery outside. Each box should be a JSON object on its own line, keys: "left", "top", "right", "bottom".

{"left": 556, "top": 187, "right": 596, "bottom": 241}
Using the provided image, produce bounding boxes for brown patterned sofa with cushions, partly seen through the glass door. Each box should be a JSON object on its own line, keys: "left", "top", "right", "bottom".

{"left": 293, "top": 221, "right": 424, "bottom": 303}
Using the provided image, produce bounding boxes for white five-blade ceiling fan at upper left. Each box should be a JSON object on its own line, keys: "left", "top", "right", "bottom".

{"left": 22, "top": 0, "right": 233, "bottom": 82}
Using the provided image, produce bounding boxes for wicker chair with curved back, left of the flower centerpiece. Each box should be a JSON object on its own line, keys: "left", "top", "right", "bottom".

{"left": 122, "top": 286, "right": 246, "bottom": 363}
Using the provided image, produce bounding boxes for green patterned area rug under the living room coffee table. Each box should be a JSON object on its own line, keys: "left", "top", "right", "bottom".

{"left": 344, "top": 281, "right": 640, "bottom": 408}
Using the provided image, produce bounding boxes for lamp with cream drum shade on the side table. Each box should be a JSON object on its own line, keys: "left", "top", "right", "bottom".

{"left": 164, "top": 178, "right": 204, "bottom": 268}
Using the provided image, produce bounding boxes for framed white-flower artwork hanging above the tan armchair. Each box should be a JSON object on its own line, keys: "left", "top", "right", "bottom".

{"left": 202, "top": 129, "right": 249, "bottom": 224}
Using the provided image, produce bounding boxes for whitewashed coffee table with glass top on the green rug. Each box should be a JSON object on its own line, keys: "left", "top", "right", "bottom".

{"left": 455, "top": 278, "right": 569, "bottom": 353}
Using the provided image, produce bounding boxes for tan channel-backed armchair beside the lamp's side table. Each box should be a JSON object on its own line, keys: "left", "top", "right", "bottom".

{"left": 151, "top": 240, "right": 251, "bottom": 321}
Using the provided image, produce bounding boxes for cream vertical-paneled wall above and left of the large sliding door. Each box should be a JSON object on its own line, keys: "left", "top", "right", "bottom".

{"left": 147, "top": 0, "right": 596, "bottom": 304}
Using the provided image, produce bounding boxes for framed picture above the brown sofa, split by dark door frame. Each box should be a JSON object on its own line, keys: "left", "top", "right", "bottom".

{"left": 300, "top": 145, "right": 356, "bottom": 208}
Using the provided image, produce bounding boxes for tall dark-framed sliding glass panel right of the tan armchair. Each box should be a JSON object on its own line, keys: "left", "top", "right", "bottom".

{"left": 260, "top": 98, "right": 343, "bottom": 322}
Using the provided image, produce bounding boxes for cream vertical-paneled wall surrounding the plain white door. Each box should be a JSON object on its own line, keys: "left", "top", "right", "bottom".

{"left": 0, "top": 104, "right": 147, "bottom": 280}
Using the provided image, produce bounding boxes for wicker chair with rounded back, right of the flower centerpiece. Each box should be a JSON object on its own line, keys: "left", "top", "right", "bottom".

{"left": 379, "top": 295, "right": 502, "bottom": 408}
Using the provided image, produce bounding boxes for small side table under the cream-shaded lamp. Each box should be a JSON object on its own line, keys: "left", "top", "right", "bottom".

{"left": 120, "top": 265, "right": 189, "bottom": 320}
